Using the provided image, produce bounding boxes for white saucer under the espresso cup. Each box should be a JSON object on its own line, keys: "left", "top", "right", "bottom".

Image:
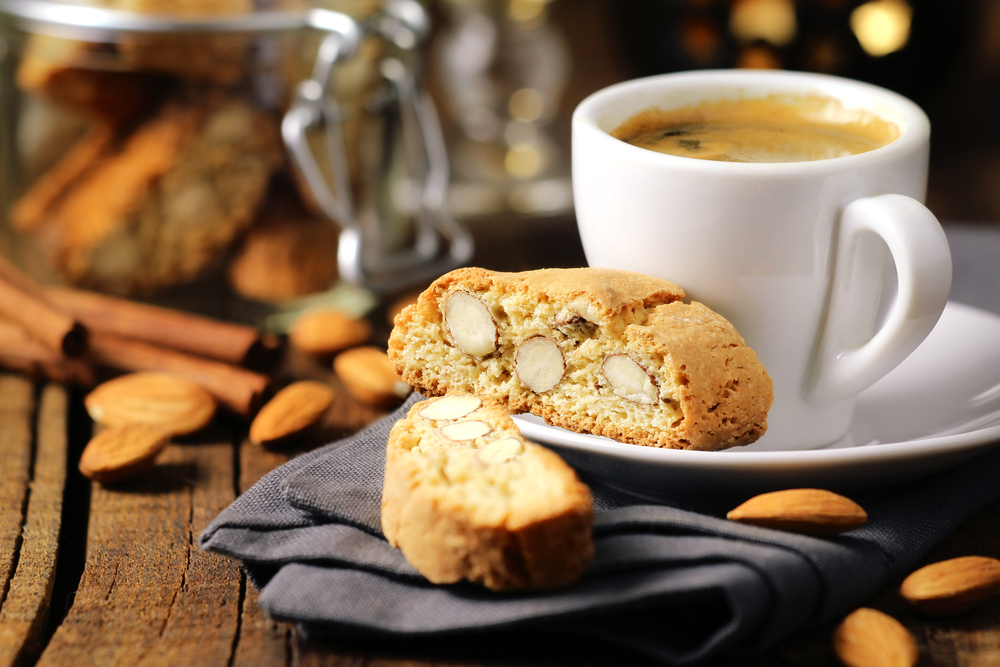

{"left": 515, "top": 303, "right": 1000, "bottom": 498}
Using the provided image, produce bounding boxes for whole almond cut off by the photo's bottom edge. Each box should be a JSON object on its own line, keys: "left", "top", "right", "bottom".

{"left": 833, "top": 607, "right": 920, "bottom": 667}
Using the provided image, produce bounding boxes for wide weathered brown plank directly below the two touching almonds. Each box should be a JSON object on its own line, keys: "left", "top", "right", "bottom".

{"left": 38, "top": 434, "right": 241, "bottom": 667}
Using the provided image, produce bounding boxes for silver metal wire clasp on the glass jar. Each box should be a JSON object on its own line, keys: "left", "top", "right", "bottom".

{"left": 281, "top": 0, "right": 473, "bottom": 293}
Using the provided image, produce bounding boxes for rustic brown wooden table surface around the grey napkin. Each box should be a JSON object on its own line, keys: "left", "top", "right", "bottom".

{"left": 0, "top": 222, "right": 1000, "bottom": 667}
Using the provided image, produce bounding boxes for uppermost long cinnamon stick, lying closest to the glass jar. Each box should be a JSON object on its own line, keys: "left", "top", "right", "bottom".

{"left": 46, "top": 287, "right": 279, "bottom": 369}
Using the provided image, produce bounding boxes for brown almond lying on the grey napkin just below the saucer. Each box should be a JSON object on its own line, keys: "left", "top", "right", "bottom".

{"left": 726, "top": 489, "right": 868, "bottom": 535}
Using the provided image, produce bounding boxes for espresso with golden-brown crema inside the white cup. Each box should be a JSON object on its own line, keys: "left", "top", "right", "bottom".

{"left": 611, "top": 95, "right": 899, "bottom": 162}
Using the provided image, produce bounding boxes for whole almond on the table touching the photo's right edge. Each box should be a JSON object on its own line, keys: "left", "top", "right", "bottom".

{"left": 899, "top": 556, "right": 1000, "bottom": 616}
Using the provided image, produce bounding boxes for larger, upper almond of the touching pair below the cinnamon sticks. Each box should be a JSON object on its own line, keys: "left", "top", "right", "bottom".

{"left": 84, "top": 372, "right": 216, "bottom": 435}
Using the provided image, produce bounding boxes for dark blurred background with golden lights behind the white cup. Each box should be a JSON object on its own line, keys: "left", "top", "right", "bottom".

{"left": 429, "top": 0, "right": 1000, "bottom": 268}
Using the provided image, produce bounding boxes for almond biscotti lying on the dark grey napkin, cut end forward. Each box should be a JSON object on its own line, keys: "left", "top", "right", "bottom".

{"left": 382, "top": 394, "right": 594, "bottom": 590}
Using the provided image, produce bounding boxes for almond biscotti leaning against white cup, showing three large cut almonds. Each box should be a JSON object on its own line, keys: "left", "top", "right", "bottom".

{"left": 389, "top": 268, "right": 773, "bottom": 450}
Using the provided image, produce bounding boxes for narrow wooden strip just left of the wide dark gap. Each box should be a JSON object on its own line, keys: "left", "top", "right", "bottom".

{"left": 0, "top": 385, "right": 68, "bottom": 667}
